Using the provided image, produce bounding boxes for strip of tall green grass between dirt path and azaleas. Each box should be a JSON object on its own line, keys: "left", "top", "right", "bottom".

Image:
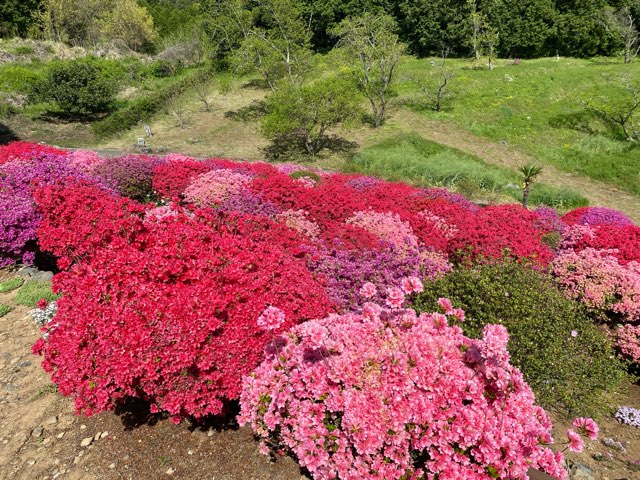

{"left": 345, "top": 133, "right": 588, "bottom": 209}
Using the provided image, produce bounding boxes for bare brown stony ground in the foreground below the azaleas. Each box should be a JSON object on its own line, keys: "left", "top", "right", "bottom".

{"left": 0, "top": 272, "right": 640, "bottom": 480}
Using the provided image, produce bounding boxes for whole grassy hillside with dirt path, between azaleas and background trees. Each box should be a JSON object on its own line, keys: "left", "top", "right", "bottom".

{"left": 0, "top": 51, "right": 640, "bottom": 215}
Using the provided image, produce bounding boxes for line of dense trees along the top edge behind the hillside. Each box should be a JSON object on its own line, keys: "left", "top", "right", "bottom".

{"left": 0, "top": 0, "right": 640, "bottom": 58}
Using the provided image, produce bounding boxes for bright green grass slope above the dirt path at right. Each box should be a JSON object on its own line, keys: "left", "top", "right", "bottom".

{"left": 399, "top": 58, "right": 640, "bottom": 195}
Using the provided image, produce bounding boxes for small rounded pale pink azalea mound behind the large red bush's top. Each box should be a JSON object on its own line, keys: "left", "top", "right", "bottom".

{"left": 184, "top": 169, "right": 253, "bottom": 207}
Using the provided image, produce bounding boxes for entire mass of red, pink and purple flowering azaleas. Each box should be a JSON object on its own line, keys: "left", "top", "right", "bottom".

{"left": 0, "top": 144, "right": 640, "bottom": 479}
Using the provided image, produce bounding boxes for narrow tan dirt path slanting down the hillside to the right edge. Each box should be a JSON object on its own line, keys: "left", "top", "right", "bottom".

{"left": 394, "top": 109, "right": 640, "bottom": 222}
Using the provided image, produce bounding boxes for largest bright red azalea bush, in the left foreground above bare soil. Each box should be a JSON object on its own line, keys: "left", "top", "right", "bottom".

{"left": 34, "top": 204, "right": 330, "bottom": 420}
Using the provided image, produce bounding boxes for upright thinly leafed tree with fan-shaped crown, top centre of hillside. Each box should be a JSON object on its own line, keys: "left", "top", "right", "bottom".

{"left": 333, "top": 13, "right": 405, "bottom": 128}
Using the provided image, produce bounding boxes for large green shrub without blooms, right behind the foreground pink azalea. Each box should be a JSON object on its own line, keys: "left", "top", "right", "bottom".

{"left": 415, "top": 262, "right": 625, "bottom": 415}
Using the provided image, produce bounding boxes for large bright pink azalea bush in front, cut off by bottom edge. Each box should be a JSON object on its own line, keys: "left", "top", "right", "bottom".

{"left": 239, "top": 298, "right": 577, "bottom": 480}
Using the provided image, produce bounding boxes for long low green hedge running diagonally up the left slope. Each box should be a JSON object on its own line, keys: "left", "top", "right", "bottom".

{"left": 91, "top": 68, "right": 212, "bottom": 138}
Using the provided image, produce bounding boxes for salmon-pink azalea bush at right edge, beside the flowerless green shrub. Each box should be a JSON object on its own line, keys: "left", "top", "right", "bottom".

{"left": 551, "top": 248, "right": 640, "bottom": 321}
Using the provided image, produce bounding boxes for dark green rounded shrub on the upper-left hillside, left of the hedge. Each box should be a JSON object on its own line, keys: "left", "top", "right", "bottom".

{"left": 33, "top": 60, "right": 117, "bottom": 118}
